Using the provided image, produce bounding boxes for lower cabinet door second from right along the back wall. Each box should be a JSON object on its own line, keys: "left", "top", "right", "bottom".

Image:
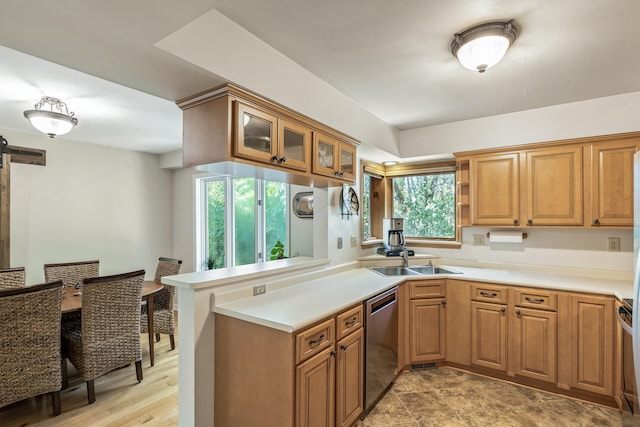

{"left": 513, "top": 308, "right": 557, "bottom": 384}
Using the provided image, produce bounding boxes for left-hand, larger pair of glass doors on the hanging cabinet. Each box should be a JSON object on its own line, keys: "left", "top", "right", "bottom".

{"left": 234, "top": 101, "right": 311, "bottom": 172}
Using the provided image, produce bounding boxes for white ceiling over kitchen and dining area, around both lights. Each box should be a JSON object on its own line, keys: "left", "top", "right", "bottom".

{"left": 0, "top": 0, "right": 640, "bottom": 153}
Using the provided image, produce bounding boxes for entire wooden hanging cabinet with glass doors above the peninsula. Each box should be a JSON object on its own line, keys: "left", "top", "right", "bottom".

{"left": 177, "top": 84, "right": 358, "bottom": 186}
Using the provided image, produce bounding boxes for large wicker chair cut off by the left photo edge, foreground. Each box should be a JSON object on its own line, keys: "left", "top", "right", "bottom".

{"left": 0, "top": 281, "right": 62, "bottom": 415}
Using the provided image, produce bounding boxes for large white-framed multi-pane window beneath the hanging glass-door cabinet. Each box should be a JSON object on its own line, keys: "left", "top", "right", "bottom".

{"left": 196, "top": 176, "right": 289, "bottom": 270}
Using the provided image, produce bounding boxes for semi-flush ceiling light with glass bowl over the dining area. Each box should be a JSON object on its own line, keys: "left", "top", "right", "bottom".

{"left": 24, "top": 96, "right": 78, "bottom": 138}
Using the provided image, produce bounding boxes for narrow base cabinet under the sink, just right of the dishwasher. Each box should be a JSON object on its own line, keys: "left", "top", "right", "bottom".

{"left": 408, "top": 280, "right": 447, "bottom": 363}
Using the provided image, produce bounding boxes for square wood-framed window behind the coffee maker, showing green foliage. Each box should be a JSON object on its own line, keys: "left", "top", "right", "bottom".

{"left": 393, "top": 172, "right": 456, "bottom": 240}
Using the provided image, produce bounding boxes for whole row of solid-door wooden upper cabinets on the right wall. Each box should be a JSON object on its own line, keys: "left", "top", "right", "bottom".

{"left": 455, "top": 133, "right": 640, "bottom": 228}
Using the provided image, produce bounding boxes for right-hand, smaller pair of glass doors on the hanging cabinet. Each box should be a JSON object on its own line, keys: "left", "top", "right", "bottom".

{"left": 312, "top": 132, "right": 356, "bottom": 181}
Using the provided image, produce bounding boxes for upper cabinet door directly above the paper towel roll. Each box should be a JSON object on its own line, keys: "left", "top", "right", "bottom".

{"left": 469, "top": 153, "right": 520, "bottom": 226}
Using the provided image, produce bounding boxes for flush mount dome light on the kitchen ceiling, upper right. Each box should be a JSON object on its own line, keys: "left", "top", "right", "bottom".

{"left": 451, "top": 20, "right": 518, "bottom": 73}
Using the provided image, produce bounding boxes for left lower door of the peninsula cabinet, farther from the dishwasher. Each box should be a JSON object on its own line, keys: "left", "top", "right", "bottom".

{"left": 296, "top": 347, "right": 336, "bottom": 427}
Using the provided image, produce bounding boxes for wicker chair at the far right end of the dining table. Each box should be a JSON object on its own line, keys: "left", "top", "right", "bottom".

{"left": 140, "top": 257, "right": 182, "bottom": 350}
